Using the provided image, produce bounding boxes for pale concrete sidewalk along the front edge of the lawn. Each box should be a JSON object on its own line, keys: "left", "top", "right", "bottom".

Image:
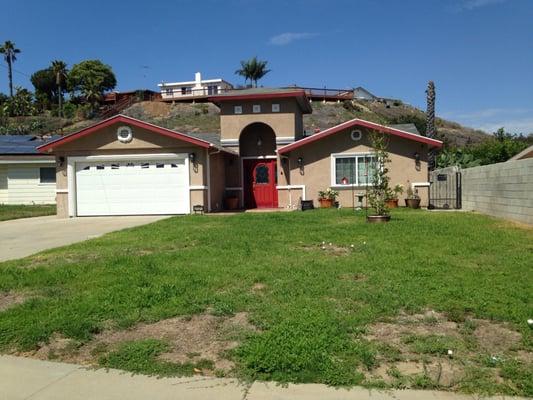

{"left": 0, "top": 356, "right": 524, "bottom": 400}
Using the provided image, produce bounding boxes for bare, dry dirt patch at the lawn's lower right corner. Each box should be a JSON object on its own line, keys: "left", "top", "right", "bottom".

{"left": 363, "top": 310, "right": 531, "bottom": 388}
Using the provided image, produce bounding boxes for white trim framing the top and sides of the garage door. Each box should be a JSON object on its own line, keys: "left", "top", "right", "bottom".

{"left": 67, "top": 153, "right": 191, "bottom": 217}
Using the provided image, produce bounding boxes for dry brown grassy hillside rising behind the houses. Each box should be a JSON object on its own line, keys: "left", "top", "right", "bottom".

{"left": 4, "top": 100, "right": 488, "bottom": 146}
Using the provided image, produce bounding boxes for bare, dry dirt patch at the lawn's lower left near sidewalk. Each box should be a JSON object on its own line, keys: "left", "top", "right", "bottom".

{"left": 25, "top": 313, "right": 256, "bottom": 372}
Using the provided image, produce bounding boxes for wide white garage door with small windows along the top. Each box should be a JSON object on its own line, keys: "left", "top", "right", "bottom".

{"left": 76, "top": 159, "right": 190, "bottom": 216}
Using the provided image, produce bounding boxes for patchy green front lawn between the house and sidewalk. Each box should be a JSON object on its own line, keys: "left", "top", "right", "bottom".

{"left": 0, "top": 209, "right": 533, "bottom": 396}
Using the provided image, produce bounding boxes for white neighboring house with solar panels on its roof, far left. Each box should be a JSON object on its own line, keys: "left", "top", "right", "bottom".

{"left": 0, "top": 135, "right": 56, "bottom": 204}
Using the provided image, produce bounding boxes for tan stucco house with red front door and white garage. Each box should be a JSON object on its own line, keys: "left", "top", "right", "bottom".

{"left": 39, "top": 88, "right": 442, "bottom": 217}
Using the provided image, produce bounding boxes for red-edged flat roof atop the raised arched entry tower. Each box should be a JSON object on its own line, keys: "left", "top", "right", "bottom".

{"left": 208, "top": 87, "right": 313, "bottom": 114}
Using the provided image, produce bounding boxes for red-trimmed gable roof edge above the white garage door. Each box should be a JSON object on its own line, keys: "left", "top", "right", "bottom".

{"left": 37, "top": 114, "right": 212, "bottom": 153}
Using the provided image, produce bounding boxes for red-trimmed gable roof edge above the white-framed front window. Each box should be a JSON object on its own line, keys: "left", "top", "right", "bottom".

{"left": 278, "top": 118, "right": 442, "bottom": 154}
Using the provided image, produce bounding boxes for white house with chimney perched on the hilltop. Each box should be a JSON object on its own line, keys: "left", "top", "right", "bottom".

{"left": 157, "top": 72, "right": 233, "bottom": 101}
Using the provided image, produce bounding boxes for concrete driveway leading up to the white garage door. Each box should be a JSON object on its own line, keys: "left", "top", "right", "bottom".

{"left": 0, "top": 215, "right": 168, "bottom": 261}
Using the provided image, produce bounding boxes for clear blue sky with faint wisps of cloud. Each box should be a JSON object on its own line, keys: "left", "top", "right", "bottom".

{"left": 0, "top": 0, "right": 533, "bottom": 133}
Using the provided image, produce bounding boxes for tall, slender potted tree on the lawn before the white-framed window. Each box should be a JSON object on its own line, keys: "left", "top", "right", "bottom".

{"left": 366, "top": 132, "right": 392, "bottom": 223}
